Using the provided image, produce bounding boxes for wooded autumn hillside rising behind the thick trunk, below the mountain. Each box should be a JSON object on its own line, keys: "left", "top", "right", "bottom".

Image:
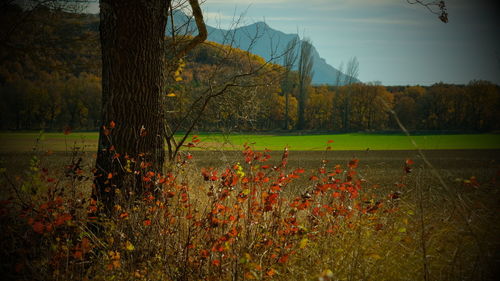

{"left": 0, "top": 6, "right": 280, "bottom": 130}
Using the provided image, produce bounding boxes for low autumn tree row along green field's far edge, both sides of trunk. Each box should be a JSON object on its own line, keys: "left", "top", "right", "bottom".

{"left": 0, "top": 70, "right": 500, "bottom": 132}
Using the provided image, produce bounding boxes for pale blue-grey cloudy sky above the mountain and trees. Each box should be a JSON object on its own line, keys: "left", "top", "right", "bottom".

{"left": 87, "top": 0, "right": 500, "bottom": 85}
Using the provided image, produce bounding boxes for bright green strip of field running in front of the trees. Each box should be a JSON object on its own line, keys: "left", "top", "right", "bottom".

{"left": 0, "top": 132, "right": 500, "bottom": 152}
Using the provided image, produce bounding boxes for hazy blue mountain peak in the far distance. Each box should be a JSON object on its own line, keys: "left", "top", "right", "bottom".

{"left": 167, "top": 11, "right": 359, "bottom": 85}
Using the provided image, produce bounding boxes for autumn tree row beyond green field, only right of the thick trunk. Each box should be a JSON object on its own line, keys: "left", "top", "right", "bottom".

{"left": 195, "top": 81, "right": 500, "bottom": 132}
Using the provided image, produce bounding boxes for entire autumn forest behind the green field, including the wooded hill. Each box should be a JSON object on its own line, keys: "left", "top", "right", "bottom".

{"left": 0, "top": 6, "right": 500, "bottom": 132}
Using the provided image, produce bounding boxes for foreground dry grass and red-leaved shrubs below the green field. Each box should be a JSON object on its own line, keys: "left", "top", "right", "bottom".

{"left": 0, "top": 145, "right": 500, "bottom": 280}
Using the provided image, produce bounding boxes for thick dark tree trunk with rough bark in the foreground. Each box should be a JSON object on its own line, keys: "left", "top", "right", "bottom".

{"left": 93, "top": 0, "right": 170, "bottom": 213}
